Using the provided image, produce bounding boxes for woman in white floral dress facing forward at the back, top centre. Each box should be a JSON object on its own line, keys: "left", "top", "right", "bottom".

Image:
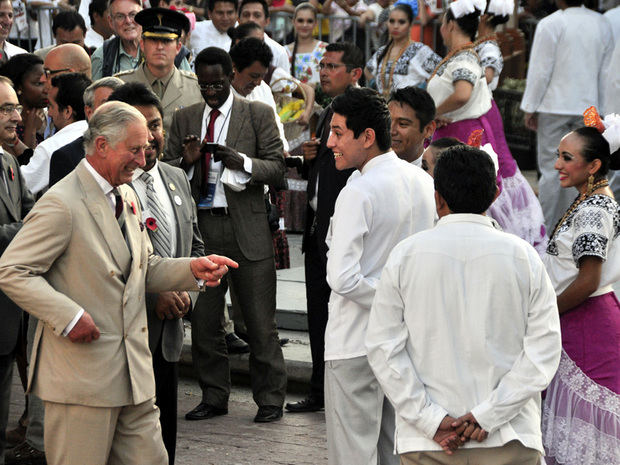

{"left": 286, "top": 2, "right": 327, "bottom": 87}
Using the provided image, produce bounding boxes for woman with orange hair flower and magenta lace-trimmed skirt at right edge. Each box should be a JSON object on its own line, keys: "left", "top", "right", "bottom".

{"left": 542, "top": 111, "right": 620, "bottom": 465}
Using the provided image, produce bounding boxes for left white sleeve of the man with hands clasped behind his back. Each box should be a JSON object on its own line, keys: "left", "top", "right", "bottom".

{"left": 366, "top": 248, "right": 448, "bottom": 439}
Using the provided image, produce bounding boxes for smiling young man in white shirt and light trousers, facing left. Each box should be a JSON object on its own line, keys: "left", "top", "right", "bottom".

{"left": 325, "top": 87, "right": 435, "bottom": 465}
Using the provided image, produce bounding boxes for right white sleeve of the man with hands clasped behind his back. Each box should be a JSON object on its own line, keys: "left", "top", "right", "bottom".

{"left": 471, "top": 251, "right": 562, "bottom": 433}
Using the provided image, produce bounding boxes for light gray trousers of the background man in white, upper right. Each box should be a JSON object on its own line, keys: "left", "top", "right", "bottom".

{"left": 537, "top": 113, "right": 583, "bottom": 228}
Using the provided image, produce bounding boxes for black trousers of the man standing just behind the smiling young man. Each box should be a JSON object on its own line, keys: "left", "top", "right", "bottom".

{"left": 304, "top": 235, "right": 331, "bottom": 399}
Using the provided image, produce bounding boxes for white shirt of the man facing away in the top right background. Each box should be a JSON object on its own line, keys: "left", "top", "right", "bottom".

{"left": 521, "top": 6, "right": 613, "bottom": 115}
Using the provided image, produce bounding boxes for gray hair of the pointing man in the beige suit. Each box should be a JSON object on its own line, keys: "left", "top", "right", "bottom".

{"left": 84, "top": 101, "right": 146, "bottom": 155}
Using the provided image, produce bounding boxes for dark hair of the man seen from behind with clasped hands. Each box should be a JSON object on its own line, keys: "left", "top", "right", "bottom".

{"left": 435, "top": 145, "right": 497, "bottom": 214}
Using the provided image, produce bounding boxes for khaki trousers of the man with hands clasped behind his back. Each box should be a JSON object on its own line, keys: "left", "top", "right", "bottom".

{"left": 400, "top": 441, "right": 540, "bottom": 465}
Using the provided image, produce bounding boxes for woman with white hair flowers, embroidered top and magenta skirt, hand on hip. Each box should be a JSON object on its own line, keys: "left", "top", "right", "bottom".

{"left": 427, "top": 0, "right": 547, "bottom": 254}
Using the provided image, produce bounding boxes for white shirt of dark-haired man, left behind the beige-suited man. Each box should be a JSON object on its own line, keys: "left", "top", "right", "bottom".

{"left": 21, "top": 120, "right": 88, "bottom": 194}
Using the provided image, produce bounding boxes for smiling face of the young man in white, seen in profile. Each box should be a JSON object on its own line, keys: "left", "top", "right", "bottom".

{"left": 327, "top": 113, "right": 372, "bottom": 170}
